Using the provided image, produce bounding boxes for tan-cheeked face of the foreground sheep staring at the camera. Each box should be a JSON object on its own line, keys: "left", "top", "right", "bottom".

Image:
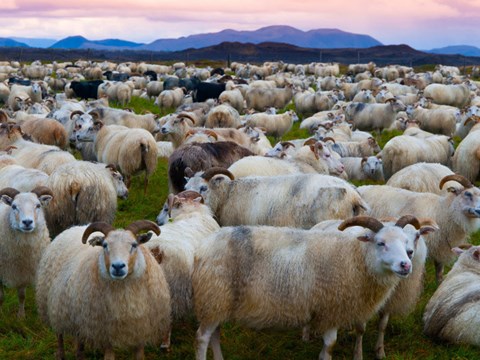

{"left": 94, "top": 230, "right": 151, "bottom": 280}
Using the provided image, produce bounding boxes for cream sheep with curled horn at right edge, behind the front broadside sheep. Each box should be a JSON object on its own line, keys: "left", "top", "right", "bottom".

{"left": 358, "top": 174, "right": 480, "bottom": 282}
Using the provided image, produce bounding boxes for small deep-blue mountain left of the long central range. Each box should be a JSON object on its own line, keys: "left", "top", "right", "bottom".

{"left": 50, "top": 36, "right": 143, "bottom": 50}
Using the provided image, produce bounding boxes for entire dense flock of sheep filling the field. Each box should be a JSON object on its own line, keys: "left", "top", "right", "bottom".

{"left": 0, "top": 57, "right": 480, "bottom": 360}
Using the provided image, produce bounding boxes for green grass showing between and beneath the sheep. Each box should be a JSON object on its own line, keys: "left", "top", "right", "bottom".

{"left": 0, "top": 95, "right": 480, "bottom": 360}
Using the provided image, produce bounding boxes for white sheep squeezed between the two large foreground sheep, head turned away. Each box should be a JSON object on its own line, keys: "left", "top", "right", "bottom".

{"left": 146, "top": 191, "right": 220, "bottom": 347}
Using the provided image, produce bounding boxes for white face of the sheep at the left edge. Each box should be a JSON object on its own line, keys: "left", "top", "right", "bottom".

{"left": 2, "top": 193, "right": 52, "bottom": 233}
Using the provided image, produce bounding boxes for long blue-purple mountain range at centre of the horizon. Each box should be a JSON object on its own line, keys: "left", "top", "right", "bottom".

{"left": 139, "top": 25, "right": 382, "bottom": 51}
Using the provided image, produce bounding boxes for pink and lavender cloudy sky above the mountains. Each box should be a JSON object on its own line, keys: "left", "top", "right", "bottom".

{"left": 0, "top": 0, "right": 480, "bottom": 50}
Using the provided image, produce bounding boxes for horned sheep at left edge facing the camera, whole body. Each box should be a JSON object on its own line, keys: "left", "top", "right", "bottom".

{"left": 0, "top": 186, "right": 53, "bottom": 318}
